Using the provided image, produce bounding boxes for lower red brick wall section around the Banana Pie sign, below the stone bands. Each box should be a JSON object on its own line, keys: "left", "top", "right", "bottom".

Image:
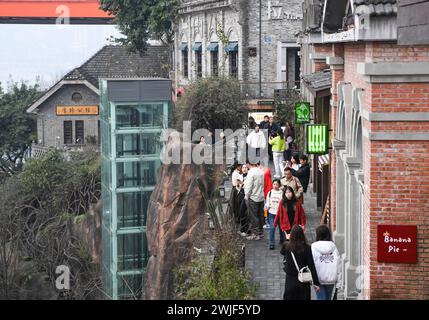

{"left": 364, "top": 141, "right": 429, "bottom": 299}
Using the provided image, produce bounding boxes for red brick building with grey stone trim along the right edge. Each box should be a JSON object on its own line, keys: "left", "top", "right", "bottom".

{"left": 300, "top": 0, "right": 429, "bottom": 299}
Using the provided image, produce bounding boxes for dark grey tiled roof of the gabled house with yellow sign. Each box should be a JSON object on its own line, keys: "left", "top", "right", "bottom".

{"left": 62, "top": 46, "right": 170, "bottom": 88}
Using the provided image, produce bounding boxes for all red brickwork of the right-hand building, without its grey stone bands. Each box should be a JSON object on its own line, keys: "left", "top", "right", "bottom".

{"left": 331, "top": 43, "right": 429, "bottom": 299}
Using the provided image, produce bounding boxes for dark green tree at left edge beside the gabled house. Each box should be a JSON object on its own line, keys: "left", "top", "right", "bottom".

{"left": 0, "top": 83, "right": 40, "bottom": 175}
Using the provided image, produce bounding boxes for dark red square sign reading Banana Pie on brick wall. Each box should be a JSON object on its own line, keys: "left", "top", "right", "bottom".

{"left": 377, "top": 225, "right": 417, "bottom": 263}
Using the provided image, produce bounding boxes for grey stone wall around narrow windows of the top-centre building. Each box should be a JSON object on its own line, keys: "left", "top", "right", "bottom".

{"left": 175, "top": 0, "right": 302, "bottom": 97}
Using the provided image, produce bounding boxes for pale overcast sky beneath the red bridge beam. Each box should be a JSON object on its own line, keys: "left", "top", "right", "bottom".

{"left": 0, "top": 24, "right": 120, "bottom": 89}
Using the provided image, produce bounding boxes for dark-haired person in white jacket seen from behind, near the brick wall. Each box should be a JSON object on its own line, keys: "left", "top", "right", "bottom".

{"left": 311, "top": 225, "right": 342, "bottom": 300}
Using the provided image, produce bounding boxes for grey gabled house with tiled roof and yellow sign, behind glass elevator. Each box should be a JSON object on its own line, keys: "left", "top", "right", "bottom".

{"left": 27, "top": 46, "right": 170, "bottom": 149}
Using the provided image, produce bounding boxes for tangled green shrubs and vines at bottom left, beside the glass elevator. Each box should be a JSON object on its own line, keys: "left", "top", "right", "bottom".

{"left": 0, "top": 150, "right": 101, "bottom": 299}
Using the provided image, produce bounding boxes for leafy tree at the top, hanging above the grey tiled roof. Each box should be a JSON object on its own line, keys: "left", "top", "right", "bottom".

{"left": 101, "top": 0, "right": 179, "bottom": 52}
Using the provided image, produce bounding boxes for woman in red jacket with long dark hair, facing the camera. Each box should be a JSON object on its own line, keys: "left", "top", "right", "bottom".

{"left": 274, "top": 187, "right": 306, "bottom": 240}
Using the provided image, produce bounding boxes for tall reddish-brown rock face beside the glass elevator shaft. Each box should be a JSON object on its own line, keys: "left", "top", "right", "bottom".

{"left": 143, "top": 139, "right": 220, "bottom": 300}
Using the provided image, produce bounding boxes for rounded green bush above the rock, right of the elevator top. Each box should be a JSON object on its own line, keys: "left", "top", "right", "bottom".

{"left": 174, "top": 78, "right": 247, "bottom": 132}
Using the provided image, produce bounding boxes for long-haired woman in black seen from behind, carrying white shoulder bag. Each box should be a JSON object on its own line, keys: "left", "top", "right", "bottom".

{"left": 280, "top": 225, "right": 320, "bottom": 300}
